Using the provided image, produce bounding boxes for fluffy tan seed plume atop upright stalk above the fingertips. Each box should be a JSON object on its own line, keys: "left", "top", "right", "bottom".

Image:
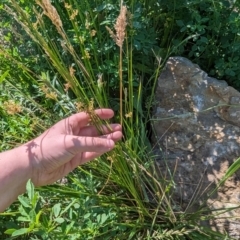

{"left": 106, "top": 6, "right": 127, "bottom": 47}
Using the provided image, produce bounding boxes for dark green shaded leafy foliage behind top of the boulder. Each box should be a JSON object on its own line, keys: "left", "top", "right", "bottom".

{"left": 157, "top": 0, "right": 240, "bottom": 89}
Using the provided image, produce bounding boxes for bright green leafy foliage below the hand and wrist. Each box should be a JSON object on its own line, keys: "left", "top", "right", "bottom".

{"left": 0, "top": 177, "right": 127, "bottom": 239}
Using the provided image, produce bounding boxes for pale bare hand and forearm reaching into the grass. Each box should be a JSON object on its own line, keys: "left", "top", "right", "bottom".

{"left": 0, "top": 109, "right": 122, "bottom": 212}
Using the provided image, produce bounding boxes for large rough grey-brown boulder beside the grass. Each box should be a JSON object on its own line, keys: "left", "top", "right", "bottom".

{"left": 152, "top": 57, "right": 240, "bottom": 239}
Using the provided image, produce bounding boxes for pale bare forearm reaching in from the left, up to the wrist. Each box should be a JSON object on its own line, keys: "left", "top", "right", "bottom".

{"left": 0, "top": 146, "right": 31, "bottom": 212}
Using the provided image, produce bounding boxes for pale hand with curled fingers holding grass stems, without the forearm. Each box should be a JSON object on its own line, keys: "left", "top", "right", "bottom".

{"left": 23, "top": 109, "right": 122, "bottom": 186}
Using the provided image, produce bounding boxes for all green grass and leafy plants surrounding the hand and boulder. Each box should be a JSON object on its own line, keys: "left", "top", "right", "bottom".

{"left": 0, "top": 0, "right": 240, "bottom": 239}
